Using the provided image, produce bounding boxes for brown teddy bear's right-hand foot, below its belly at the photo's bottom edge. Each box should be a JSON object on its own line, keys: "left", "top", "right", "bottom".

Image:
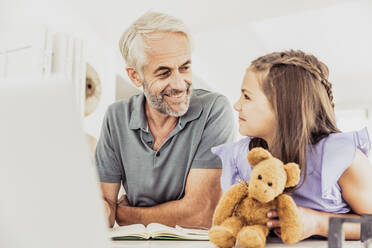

{"left": 237, "top": 227, "right": 266, "bottom": 248}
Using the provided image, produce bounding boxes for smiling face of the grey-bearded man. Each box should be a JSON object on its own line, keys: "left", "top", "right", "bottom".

{"left": 143, "top": 32, "right": 192, "bottom": 117}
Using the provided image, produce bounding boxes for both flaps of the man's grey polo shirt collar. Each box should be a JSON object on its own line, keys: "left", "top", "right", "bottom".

{"left": 129, "top": 91, "right": 203, "bottom": 132}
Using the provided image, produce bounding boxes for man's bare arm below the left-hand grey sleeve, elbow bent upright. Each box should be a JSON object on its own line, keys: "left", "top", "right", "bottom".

{"left": 100, "top": 182, "right": 120, "bottom": 227}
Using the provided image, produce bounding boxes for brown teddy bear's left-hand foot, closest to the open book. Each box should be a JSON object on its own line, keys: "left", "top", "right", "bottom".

{"left": 208, "top": 226, "right": 236, "bottom": 248}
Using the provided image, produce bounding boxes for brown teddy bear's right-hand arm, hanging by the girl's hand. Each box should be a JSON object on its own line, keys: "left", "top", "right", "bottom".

{"left": 276, "top": 194, "right": 302, "bottom": 244}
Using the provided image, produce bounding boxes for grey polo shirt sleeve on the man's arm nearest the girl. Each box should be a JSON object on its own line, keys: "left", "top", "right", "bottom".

{"left": 191, "top": 95, "right": 234, "bottom": 168}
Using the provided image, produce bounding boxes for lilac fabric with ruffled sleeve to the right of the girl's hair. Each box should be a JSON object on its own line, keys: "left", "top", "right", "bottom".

{"left": 292, "top": 128, "right": 371, "bottom": 213}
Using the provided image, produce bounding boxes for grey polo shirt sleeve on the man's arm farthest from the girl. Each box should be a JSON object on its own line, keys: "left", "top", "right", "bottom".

{"left": 95, "top": 107, "right": 122, "bottom": 183}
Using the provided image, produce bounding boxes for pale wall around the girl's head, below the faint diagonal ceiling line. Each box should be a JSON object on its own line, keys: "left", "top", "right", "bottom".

{"left": 190, "top": 1, "right": 372, "bottom": 143}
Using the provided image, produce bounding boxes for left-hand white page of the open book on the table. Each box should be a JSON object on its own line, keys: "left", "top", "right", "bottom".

{"left": 109, "top": 224, "right": 150, "bottom": 239}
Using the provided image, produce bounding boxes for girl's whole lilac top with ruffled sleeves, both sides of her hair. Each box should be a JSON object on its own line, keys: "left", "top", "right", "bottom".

{"left": 212, "top": 128, "right": 371, "bottom": 213}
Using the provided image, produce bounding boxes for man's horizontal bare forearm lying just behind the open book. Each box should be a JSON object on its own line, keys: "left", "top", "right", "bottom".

{"left": 116, "top": 199, "right": 215, "bottom": 228}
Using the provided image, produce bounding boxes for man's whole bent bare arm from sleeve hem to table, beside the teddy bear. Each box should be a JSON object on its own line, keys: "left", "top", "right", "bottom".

{"left": 116, "top": 169, "right": 221, "bottom": 228}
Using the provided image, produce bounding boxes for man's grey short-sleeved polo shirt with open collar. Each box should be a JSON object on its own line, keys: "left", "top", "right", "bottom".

{"left": 95, "top": 89, "right": 234, "bottom": 206}
